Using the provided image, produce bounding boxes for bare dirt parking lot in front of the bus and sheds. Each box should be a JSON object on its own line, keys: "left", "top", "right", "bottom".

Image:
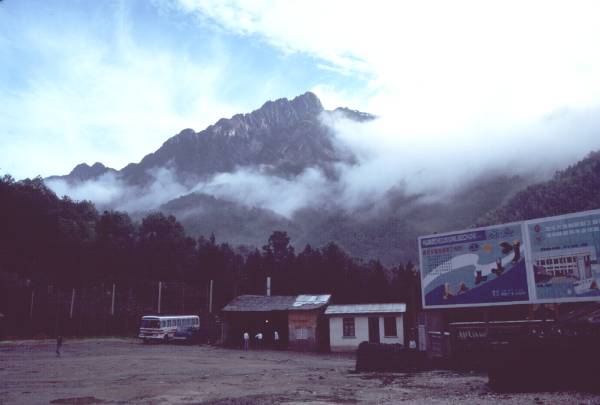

{"left": 0, "top": 338, "right": 600, "bottom": 405}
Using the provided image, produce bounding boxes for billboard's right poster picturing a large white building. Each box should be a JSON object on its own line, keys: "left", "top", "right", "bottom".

{"left": 526, "top": 211, "right": 600, "bottom": 302}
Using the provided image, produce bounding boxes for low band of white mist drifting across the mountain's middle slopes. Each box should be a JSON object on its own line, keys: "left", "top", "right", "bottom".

{"left": 46, "top": 163, "right": 336, "bottom": 218}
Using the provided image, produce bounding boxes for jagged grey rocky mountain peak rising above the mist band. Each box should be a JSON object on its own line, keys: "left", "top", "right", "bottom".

{"left": 52, "top": 92, "right": 370, "bottom": 185}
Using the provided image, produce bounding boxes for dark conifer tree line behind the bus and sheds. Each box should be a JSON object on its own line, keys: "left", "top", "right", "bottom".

{"left": 0, "top": 175, "right": 420, "bottom": 307}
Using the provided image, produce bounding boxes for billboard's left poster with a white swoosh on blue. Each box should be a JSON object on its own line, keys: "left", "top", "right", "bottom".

{"left": 419, "top": 223, "right": 530, "bottom": 308}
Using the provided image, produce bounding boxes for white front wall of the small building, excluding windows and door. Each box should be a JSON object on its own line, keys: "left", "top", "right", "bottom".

{"left": 329, "top": 314, "right": 404, "bottom": 352}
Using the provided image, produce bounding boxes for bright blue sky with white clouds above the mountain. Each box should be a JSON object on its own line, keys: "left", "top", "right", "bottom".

{"left": 0, "top": 0, "right": 600, "bottom": 193}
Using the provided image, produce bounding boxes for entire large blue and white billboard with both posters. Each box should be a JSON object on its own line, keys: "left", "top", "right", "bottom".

{"left": 418, "top": 210, "right": 600, "bottom": 308}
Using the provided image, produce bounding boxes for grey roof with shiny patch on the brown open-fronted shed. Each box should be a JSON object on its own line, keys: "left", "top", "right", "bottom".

{"left": 223, "top": 295, "right": 331, "bottom": 312}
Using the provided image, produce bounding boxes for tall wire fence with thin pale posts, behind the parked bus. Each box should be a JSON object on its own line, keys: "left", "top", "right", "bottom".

{"left": 0, "top": 274, "right": 210, "bottom": 339}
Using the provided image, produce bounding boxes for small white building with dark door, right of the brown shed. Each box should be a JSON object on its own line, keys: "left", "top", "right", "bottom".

{"left": 325, "top": 303, "right": 406, "bottom": 352}
